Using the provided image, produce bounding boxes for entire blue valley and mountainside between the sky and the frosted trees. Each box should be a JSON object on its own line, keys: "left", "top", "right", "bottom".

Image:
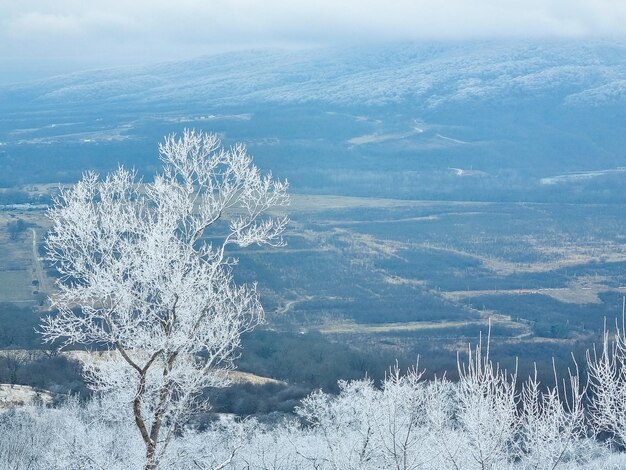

{"left": 0, "top": 40, "right": 626, "bottom": 408}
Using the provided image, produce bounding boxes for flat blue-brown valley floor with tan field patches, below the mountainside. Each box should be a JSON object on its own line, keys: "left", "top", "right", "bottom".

{"left": 0, "top": 187, "right": 626, "bottom": 379}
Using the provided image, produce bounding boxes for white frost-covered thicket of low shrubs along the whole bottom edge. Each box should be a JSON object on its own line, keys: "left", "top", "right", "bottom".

{"left": 0, "top": 352, "right": 626, "bottom": 470}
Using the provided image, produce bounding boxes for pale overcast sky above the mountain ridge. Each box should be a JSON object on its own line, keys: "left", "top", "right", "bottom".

{"left": 0, "top": 0, "right": 626, "bottom": 83}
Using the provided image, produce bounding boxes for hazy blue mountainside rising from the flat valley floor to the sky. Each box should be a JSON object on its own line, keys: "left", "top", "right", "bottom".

{"left": 0, "top": 41, "right": 626, "bottom": 202}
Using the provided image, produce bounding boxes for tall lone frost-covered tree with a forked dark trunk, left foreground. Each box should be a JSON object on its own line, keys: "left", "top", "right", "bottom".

{"left": 42, "top": 131, "right": 288, "bottom": 469}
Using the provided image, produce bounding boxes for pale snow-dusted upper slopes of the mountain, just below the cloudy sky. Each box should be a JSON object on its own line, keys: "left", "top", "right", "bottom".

{"left": 3, "top": 42, "right": 626, "bottom": 109}
